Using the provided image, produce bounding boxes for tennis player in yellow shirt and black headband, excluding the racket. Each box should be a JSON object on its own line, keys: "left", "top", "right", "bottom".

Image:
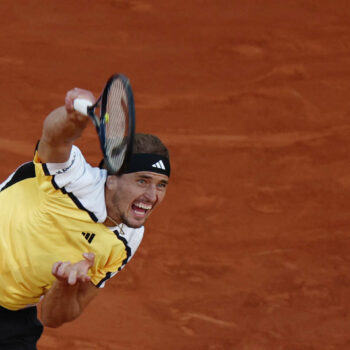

{"left": 0, "top": 89, "right": 170, "bottom": 350}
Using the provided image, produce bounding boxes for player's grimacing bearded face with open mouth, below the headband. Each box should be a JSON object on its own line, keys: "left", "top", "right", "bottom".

{"left": 106, "top": 171, "right": 169, "bottom": 228}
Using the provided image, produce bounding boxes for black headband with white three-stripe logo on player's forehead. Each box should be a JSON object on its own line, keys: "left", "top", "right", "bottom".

{"left": 122, "top": 153, "right": 170, "bottom": 176}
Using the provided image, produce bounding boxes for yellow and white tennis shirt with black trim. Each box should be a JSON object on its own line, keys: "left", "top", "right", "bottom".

{"left": 0, "top": 146, "right": 143, "bottom": 310}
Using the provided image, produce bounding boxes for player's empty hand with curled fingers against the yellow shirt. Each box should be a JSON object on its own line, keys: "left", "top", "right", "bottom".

{"left": 52, "top": 253, "right": 95, "bottom": 285}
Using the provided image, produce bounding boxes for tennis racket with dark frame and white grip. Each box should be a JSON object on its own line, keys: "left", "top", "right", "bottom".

{"left": 73, "top": 74, "right": 135, "bottom": 174}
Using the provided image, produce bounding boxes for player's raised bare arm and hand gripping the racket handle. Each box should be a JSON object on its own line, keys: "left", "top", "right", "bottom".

{"left": 38, "top": 88, "right": 95, "bottom": 163}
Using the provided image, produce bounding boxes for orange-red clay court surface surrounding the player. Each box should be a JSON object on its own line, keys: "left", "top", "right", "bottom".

{"left": 0, "top": 0, "right": 350, "bottom": 350}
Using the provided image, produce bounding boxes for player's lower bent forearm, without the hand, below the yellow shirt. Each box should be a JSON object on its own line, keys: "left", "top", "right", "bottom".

{"left": 41, "top": 280, "right": 84, "bottom": 328}
